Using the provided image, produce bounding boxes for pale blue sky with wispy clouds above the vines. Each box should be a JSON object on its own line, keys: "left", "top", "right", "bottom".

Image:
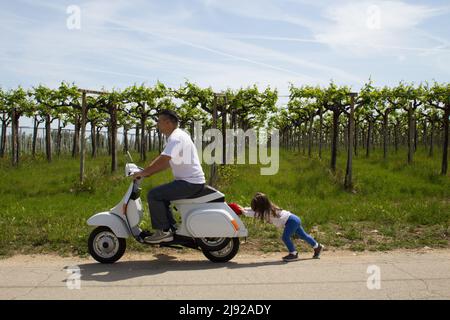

{"left": 0, "top": 0, "right": 450, "bottom": 100}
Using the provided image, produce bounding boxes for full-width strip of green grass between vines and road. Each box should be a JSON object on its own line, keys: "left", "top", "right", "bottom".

{"left": 0, "top": 146, "right": 450, "bottom": 255}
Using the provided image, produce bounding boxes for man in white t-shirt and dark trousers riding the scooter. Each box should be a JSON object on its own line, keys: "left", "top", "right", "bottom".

{"left": 133, "top": 110, "right": 205, "bottom": 244}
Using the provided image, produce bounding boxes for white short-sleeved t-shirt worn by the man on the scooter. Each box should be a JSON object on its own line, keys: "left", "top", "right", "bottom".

{"left": 161, "top": 128, "right": 206, "bottom": 184}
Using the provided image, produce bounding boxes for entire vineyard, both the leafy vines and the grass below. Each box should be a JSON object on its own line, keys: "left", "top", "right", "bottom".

{"left": 0, "top": 81, "right": 450, "bottom": 253}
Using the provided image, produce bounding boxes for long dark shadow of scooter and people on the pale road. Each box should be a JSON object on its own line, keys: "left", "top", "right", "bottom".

{"left": 73, "top": 254, "right": 311, "bottom": 282}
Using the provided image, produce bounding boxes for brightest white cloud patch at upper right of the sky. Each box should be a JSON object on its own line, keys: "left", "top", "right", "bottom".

{"left": 313, "top": 1, "right": 442, "bottom": 55}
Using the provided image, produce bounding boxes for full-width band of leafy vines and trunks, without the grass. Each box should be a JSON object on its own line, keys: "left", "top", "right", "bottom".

{"left": 0, "top": 81, "right": 450, "bottom": 180}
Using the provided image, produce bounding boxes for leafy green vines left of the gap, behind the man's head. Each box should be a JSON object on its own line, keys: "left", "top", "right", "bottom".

{"left": 0, "top": 81, "right": 277, "bottom": 184}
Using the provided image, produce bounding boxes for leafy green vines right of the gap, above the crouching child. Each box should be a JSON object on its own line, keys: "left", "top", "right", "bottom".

{"left": 271, "top": 80, "right": 450, "bottom": 187}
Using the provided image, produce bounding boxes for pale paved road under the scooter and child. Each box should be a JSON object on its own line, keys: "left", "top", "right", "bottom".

{"left": 0, "top": 250, "right": 450, "bottom": 299}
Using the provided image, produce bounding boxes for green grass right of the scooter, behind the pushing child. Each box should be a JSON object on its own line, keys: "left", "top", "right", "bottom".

{"left": 221, "top": 146, "right": 450, "bottom": 254}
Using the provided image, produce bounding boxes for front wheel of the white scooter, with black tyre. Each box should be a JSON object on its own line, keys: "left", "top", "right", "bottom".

{"left": 88, "top": 226, "right": 127, "bottom": 263}
